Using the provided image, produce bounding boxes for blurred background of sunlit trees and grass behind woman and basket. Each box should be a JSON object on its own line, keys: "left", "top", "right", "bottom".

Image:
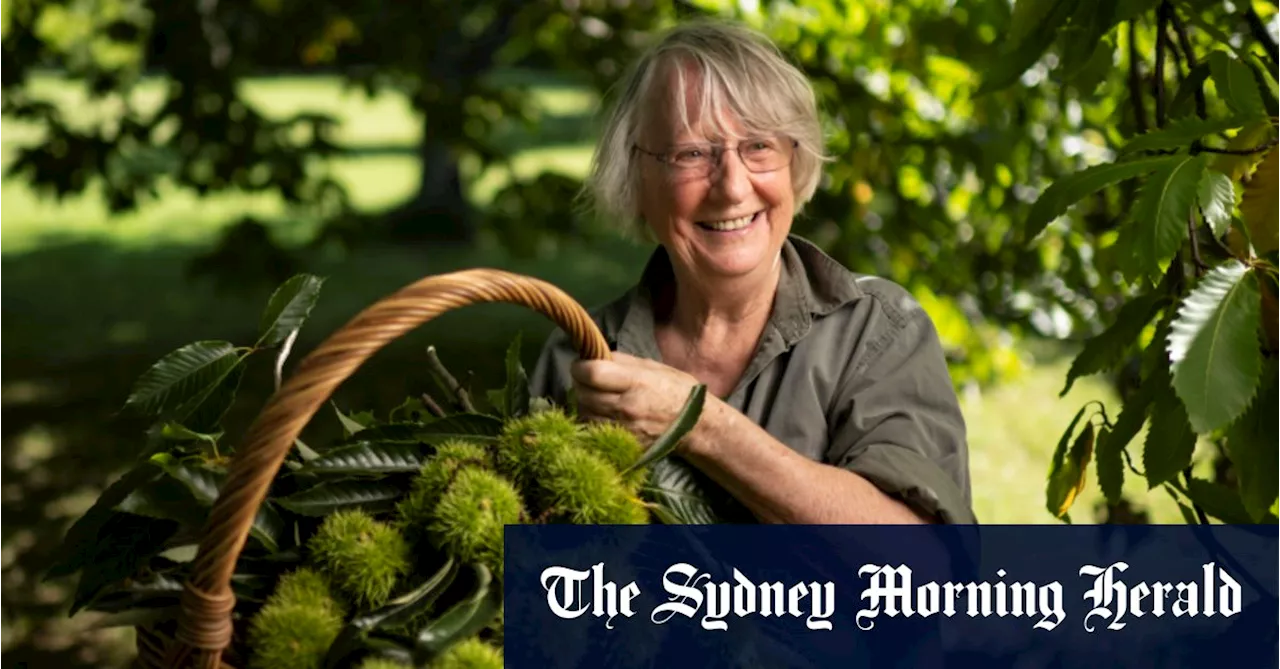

{"left": 0, "top": 0, "right": 1276, "bottom": 666}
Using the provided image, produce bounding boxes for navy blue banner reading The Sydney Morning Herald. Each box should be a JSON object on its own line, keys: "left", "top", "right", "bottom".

{"left": 504, "top": 524, "right": 1280, "bottom": 669}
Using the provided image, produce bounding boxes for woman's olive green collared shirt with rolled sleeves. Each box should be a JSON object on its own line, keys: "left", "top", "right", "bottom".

{"left": 530, "top": 235, "right": 977, "bottom": 523}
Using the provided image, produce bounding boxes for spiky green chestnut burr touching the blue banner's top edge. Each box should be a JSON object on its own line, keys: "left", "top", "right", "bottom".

{"left": 541, "top": 446, "right": 649, "bottom": 524}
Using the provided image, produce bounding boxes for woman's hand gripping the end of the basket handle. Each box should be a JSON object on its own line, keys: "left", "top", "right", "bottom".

{"left": 570, "top": 353, "right": 699, "bottom": 446}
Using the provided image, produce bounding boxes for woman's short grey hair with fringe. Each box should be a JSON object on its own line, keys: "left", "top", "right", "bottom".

{"left": 582, "top": 20, "right": 828, "bottom": 235}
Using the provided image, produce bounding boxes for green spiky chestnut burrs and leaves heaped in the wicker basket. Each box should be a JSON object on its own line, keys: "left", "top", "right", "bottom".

{"left": 47, "top": 275, "right": 718, "bottom": 668}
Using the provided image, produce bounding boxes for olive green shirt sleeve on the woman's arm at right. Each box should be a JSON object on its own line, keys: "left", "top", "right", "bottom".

{"left": 827, "top": 290, "right": 977, "bottom": 524}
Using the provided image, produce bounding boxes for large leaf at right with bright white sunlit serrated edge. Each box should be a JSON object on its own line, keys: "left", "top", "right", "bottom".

{"left": 1169, "top": 260, "right": 1262, "bottom": 435}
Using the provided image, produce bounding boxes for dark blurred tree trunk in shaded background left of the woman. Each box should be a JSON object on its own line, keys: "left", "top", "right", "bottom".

{"left": 388, "top": 114, "right": 475, "bottom": 243}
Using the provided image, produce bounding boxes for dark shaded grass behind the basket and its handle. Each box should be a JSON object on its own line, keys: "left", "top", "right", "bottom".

{"left": 0, "top": 232, "right": 645, "bottom": 669}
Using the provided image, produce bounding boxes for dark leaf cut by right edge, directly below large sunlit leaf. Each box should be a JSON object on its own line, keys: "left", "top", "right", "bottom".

{"left": 1226, "top": 363, "right": 1280, "bottom": 522}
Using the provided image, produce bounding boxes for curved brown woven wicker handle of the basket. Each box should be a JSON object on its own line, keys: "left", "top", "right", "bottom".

{"left": 164, "top": 269, "right": 609, "bottom": 669}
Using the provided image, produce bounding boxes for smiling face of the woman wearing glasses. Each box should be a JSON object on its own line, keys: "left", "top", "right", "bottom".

{"left": 637, "top": 68, "right": 795, "bottom": 289}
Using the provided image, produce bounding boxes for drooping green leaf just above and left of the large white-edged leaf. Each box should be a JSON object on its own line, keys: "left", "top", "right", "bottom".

{"left": 1121, "top": 155, "right": 1208, "bottom": 276}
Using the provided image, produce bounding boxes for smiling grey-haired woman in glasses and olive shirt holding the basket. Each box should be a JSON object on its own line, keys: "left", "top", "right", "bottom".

{"left": 531, "top": 18, "right": 975, "bottom": 524}
